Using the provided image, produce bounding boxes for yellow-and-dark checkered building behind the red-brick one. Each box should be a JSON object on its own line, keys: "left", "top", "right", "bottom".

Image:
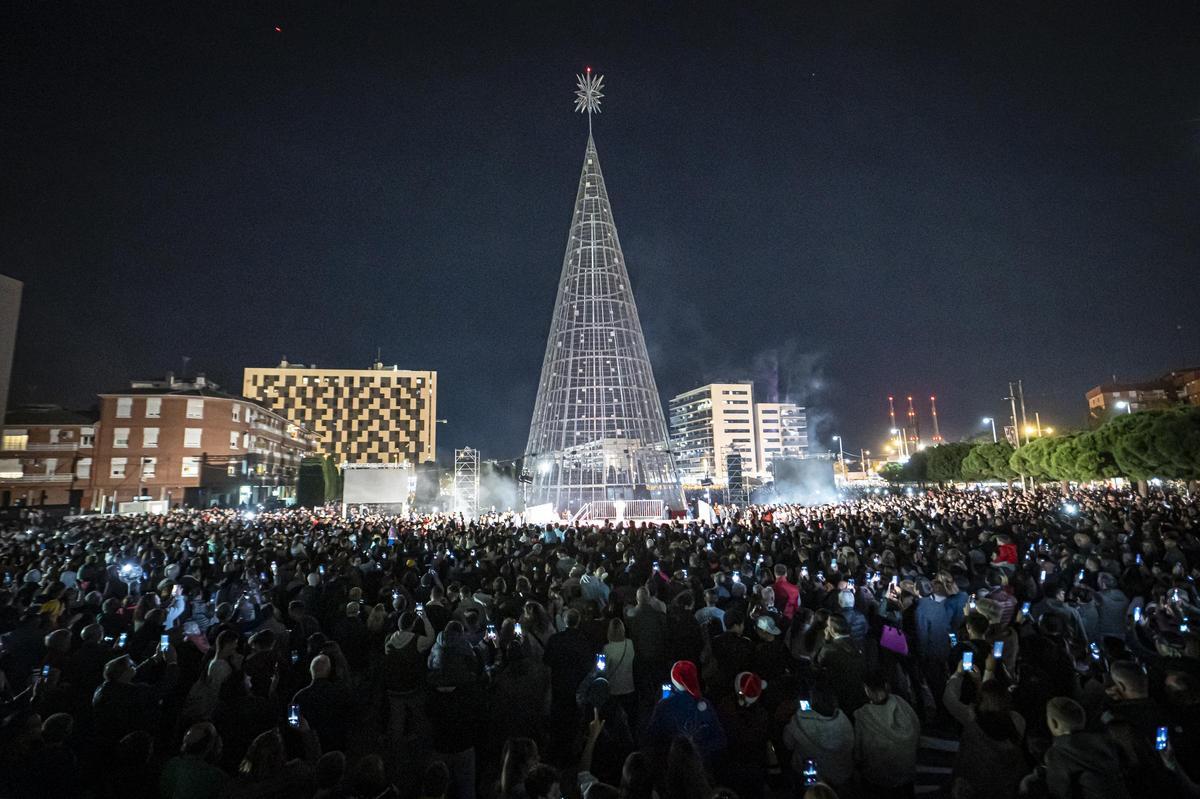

{"left": 241, "top": 361, "right": 438, "bottom": 465}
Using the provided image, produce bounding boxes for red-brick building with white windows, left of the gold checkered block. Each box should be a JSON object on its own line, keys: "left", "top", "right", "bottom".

{"left": 91, "top": 374, "right": 316, "bottom": 510}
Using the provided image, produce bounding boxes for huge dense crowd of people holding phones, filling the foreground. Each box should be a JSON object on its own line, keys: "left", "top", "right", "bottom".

{"left": 0, "top": 487, "right": 1200, "bottom": 799}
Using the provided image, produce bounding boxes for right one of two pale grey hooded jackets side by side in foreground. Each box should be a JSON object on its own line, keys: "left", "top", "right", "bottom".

{"left": 854, "top": 696, "right": 920, "bottom": 788}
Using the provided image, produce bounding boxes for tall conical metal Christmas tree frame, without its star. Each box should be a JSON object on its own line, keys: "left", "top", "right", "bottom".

{"left": 524, "top": 130, "right": 683, "bottom": 512}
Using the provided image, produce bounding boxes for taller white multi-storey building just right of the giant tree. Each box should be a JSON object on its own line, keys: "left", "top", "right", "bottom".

{"left": 670, "top": 383, "right": 758, "bottom": 488}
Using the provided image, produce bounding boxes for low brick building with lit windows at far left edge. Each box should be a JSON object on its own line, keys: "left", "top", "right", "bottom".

{"left": 0, "top": 405, "right": 96, "bottom": 509}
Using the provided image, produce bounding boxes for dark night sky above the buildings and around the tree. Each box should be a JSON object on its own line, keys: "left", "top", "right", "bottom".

{"left": 0, "top": 0, "right": 1200, "bottom": 458}
